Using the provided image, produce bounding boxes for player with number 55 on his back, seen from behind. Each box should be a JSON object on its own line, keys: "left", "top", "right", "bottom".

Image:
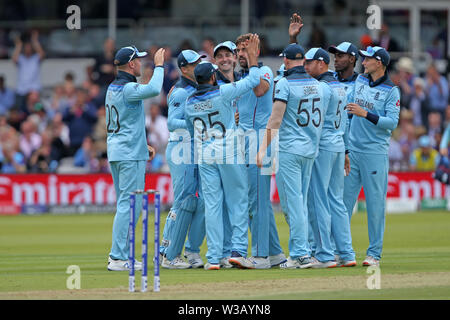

{"left": 257, "top": 43, "right": 330, "bottom": 269}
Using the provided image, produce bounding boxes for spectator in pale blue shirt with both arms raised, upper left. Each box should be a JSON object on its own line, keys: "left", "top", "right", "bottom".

{"left": 12, "top": 30, "right": 45, "bottom": 112}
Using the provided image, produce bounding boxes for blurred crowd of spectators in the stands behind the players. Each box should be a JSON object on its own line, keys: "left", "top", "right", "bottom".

{"left": 0, "top": 27, "right": 450, "bottom": 173}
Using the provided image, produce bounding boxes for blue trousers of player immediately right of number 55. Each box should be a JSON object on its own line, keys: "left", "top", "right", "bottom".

{"left": 308, "top": 150, "right": 355, "bottom": 262}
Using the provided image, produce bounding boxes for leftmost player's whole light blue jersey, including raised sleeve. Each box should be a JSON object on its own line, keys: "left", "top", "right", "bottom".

{"left": 105, "top": 67, "right": 164, "bottom": 161}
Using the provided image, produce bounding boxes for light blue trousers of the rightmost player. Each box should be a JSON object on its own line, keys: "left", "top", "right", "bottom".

{"left": 344, "top": 151, "right": 389, "bottom": 260}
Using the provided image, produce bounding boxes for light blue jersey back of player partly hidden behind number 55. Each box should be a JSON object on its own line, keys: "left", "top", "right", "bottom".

{"left": 318, "top": 72, "right": 347, "bottom": 152}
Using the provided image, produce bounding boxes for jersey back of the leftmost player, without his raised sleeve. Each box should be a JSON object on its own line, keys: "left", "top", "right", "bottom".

{"left": 105, "top": 71, "right": 148, "bottom": 161}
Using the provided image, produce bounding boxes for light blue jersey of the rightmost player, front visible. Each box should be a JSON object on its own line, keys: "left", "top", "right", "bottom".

{"left": 349, "top": 73, "right": 400, "bottom": 154}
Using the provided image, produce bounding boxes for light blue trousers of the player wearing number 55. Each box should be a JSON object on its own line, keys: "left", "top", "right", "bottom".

{"left": 276, "top": 152, "right": 314, "bottom": 259}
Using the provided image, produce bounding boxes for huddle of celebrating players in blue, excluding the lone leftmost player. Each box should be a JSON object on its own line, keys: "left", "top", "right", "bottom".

{"left": 156, "top": 14, "right": 400, "bottom": 270}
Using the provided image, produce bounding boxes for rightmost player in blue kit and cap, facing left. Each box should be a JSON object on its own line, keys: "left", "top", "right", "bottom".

{"left": 344, "top": 46, "right": 400, "bottom": 266}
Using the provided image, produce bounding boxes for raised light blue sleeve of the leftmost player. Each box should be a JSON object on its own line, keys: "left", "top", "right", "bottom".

{"left": 123, "top": 67, "right": 164, "bottom": 101}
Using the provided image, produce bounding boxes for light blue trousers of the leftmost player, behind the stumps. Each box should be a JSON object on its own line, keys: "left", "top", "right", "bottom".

{"left": 109, "top": 160, "right": 146, "bottom": 260}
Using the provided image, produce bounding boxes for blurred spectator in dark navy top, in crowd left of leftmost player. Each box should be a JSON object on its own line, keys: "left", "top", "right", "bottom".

{"left": 63, "top": 89, "right": 97, "bottom": 155}
